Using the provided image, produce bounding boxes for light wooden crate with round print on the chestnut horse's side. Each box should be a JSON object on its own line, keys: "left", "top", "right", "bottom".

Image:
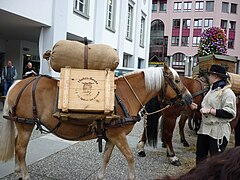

{"left": 58, "top": 68, "right": 115, "bottom": 114}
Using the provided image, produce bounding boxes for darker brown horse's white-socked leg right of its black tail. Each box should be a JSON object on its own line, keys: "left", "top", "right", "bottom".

{"left": 162, "top": 115, "right": 181, "bottom": 166}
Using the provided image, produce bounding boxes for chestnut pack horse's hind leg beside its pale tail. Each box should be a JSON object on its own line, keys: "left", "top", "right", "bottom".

{"left": 15, "top": 123, "right": 34, "bottom": 180}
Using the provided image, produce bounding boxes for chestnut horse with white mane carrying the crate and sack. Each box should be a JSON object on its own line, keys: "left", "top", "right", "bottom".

{"left": 0, "top": 65, "right": 192, "bottom": 180}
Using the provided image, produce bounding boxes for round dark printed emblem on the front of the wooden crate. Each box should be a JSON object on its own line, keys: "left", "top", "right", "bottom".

{"left": 75, "top": 77, "right": 100, "bottom": 101}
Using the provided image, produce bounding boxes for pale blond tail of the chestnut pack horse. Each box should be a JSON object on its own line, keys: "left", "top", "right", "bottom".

{"left": 0, "top": 81, "right": 19, "bottom": 162}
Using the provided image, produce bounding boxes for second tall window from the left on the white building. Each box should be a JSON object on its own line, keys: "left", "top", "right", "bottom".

{"left": 106, "top": 0, "right": 115, "bottom": 31}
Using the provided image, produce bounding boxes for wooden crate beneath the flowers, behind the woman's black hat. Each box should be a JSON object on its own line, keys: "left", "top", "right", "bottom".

{"left": 198, "top": 54, "right": 237, "bottom": 73}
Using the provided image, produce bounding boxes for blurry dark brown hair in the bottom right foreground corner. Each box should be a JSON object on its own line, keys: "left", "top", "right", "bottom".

{"left": 158, "top": 147, "right": 240, "bottom": 180}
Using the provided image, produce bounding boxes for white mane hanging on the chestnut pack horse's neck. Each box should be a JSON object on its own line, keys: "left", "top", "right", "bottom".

{"left": 143, "top": 67, "right": 163, "bottom": 91}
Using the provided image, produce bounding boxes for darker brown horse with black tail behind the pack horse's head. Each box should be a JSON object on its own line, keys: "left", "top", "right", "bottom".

{"left": 137, "top": 76, "right": 208, "bottom": 166}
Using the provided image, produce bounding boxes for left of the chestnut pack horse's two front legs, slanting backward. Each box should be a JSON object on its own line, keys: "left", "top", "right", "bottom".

{"left": 98, "top": 140, "right": 114, "bottom": 179}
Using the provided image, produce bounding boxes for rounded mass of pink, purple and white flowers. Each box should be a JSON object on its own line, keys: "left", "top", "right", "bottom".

{"left": 198, "top": 27, "right": 227, "bottom": 57}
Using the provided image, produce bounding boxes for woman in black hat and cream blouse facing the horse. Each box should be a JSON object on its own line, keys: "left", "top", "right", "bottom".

{"left": 191, "top": 64, "right": 236, "bottom": 164}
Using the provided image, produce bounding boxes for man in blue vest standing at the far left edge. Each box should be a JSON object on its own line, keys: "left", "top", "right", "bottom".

{"left": 2, "top": 60, "right": 17, "bottom": 96}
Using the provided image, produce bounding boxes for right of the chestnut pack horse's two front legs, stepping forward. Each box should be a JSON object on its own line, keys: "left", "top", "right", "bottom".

{"left": 111, "top": 132, "right": 135, "bottom": 180}
